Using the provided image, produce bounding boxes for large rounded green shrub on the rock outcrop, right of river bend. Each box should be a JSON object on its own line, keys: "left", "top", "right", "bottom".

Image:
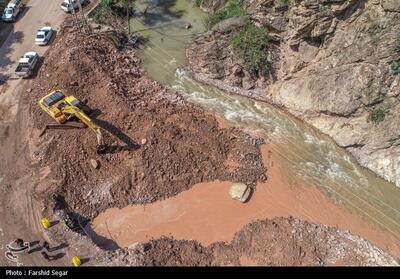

{"left": 232, "top": 23, "right": 268, "bottom": 75}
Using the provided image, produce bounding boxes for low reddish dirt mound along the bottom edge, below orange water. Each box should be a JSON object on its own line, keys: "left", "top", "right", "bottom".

{"left": 102, "top": 218, "right": 398, "bottom": 266}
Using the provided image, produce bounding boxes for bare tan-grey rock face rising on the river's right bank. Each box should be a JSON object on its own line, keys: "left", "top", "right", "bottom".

{"left": 187, "top": 0, "right": 400, "bottom": 186}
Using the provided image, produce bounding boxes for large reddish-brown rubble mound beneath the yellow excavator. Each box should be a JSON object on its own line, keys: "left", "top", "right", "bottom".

{"left": 24, "top": 22, "right": 266, "bottom": 218}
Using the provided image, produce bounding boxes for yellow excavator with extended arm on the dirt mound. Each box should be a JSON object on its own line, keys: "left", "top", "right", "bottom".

{"left": 39, "top": 90, "right": 106, "bottom": 153}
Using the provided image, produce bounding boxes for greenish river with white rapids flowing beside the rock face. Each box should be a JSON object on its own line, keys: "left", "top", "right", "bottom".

{"left": 131, "top": 0, "right": 400, "bottom": 240}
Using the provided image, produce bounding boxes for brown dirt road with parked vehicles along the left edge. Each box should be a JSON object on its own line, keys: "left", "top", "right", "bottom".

{"left": 0, "top": 0, "right": 65, "bottom": 265}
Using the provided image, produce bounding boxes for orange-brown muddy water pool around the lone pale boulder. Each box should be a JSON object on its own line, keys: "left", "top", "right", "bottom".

{"left": 93, "top": 145, "right": 400, "bottom": 256}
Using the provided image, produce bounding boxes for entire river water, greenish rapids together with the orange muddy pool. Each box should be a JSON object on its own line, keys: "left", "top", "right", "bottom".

{"left": 95, "top": 0, "right": 400, "bottom": 253}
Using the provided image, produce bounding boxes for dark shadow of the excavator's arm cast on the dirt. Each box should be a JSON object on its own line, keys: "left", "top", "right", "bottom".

{"left": 93, "top": 118, "right": 140, "bottom": 154}
